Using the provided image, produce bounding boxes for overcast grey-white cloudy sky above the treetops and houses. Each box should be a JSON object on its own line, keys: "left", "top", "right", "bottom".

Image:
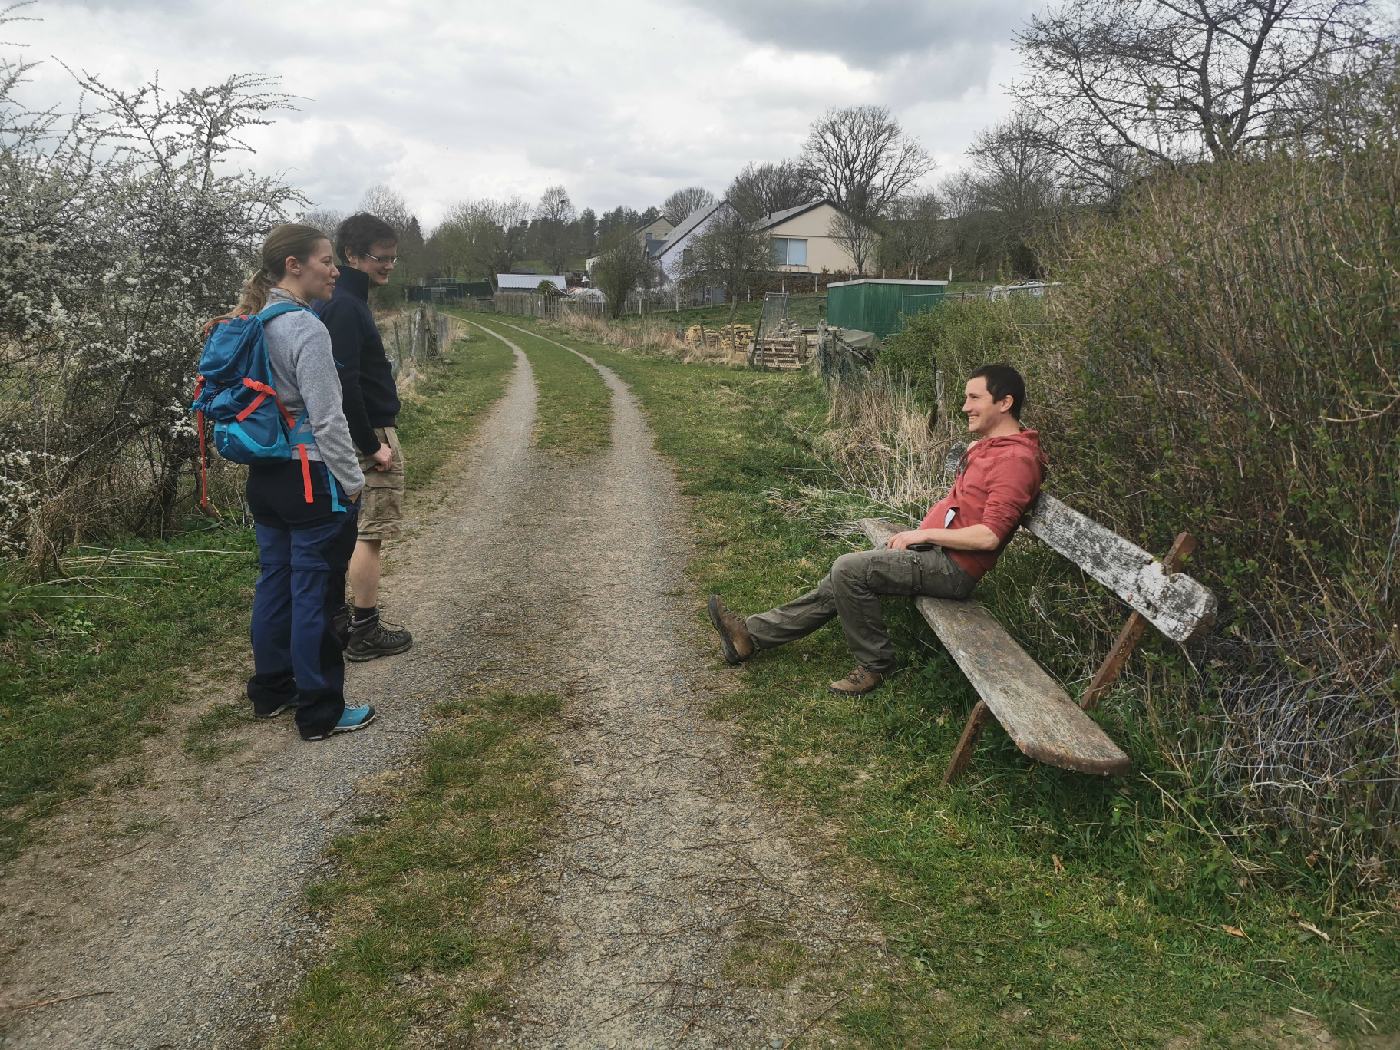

{"left": 8, "top": 0, "right": 1044, "bottom": 228}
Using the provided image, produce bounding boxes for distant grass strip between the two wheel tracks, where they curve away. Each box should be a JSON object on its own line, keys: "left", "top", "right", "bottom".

{"left": 465, "top": 314, "right": 612, "bottom": 455}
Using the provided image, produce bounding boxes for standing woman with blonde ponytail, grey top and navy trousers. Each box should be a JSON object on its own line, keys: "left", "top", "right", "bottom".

{"left": 223, "top": 224, "right": 374, "bottom": 741}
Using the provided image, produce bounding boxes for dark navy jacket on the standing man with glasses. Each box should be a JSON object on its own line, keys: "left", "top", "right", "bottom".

{"left": 316, "top": 266, "right": 399, "bottom": 456}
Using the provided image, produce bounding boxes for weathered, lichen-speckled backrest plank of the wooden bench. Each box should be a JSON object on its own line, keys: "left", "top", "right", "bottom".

{"left": 1021, "top": 493, "right": 1215, "bottom": 641}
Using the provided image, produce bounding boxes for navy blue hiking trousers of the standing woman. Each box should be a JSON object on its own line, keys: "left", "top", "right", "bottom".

{"left": 248, "top": 463, "right": 357, "bottom": 736}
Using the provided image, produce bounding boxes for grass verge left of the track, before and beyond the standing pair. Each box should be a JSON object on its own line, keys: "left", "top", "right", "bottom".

{"left": 0, "top": 333, "right": 514, "bottom": 860}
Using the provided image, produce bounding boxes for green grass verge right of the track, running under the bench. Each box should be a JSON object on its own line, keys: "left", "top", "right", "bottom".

{"left": 498, "top": 322, "right": 1400, "bottom": 1050}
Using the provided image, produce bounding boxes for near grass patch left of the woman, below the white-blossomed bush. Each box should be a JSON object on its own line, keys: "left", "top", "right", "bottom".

{"left": 0, "top": 524, "right": 256, "bottom": 858}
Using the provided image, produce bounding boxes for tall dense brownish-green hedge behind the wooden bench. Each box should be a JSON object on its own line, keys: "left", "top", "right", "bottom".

{"left": 882, "top": 133, "right": 1400, "bottom": 875}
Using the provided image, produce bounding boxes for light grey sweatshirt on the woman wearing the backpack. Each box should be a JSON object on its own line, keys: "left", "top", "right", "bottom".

{"left": 265, "top": 288, "right": 364, "bottom": 496}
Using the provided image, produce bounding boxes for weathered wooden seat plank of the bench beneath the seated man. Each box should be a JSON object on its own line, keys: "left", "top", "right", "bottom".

{"left": 861, "top": 518, "right": 1131, "bottom": 776}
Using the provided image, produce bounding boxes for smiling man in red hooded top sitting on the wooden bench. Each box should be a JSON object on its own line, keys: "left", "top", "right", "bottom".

{"left": 710, "top": 364, "right": 1044, "bottom": 696}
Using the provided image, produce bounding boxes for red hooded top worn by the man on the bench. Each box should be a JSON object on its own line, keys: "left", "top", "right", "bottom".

{"left": 918, "top": 430, "right": 1046, "bottom": 580}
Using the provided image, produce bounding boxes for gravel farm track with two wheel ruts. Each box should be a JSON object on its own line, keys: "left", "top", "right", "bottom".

{"left": 0, "top": 321, "right": 883, "bottom": 1049}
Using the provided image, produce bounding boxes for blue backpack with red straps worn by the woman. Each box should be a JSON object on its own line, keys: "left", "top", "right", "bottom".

{"left": 190, "top": 302, "right": 315, "bottom": 508}
